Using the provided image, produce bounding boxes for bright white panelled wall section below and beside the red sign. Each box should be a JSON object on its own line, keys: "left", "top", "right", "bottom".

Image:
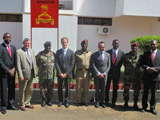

{"left": 23, "top": 14, "right": 77, "bottom": 54}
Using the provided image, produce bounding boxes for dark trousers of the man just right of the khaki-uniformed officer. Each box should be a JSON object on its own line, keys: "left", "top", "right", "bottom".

{"left": 94, "top": 77, "right": 107, "bottom": 103}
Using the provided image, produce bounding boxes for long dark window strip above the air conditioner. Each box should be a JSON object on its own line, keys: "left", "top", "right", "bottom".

{"left": 78, "top": 17, "right": 112, "bottom": 26}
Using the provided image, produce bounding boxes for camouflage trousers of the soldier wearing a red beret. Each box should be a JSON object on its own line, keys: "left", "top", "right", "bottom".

{"left": 123, "top": 77, "right": 141, "bottom": 102}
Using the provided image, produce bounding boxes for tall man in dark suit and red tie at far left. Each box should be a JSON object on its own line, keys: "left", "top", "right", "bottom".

{"left": 0, "top": 33, "right": 18, "bottom": 114}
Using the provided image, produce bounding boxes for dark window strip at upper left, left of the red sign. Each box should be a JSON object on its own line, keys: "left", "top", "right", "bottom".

{"left": 0, "top": 14, "right": 22, "bottom": 22}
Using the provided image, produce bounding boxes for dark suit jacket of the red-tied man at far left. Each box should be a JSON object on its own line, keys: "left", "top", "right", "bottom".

{"left": 0, "top": 43, "right": 16, "bottom": 77}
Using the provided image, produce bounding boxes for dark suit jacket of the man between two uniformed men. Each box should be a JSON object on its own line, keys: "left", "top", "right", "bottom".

{"left": 56, "top": 48, "right": 75, "bottom": 78}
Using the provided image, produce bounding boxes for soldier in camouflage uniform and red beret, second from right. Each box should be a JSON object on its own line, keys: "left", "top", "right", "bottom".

{"left": 123, "top": 43, "right": 141, "bottom": 110}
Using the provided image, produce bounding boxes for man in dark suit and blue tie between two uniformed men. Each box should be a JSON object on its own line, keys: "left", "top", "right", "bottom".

{"left": 56, "top": 37, "right": 75, "bottom": 108}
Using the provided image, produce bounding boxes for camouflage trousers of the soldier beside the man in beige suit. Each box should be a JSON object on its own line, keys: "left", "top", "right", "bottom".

{"left": 39, "top": 79, "right": 54, "bottom": 100}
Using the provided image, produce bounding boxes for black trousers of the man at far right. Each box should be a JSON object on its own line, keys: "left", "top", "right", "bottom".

{"left": 142, "top": 79, "right": 159, "bottom": 109}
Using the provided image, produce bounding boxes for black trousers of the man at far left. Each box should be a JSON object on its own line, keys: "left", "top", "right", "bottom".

{"left": 0, "top": 75, "right": 15, "bottom": 108}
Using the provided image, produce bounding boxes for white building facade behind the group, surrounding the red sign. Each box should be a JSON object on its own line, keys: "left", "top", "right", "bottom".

{"left": 0, "top": 0, "right": 160, "bottom": 53}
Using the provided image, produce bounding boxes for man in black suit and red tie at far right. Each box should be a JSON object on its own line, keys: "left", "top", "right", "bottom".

{"left": 141, "top": 40, "right": 160, "bottom": 115}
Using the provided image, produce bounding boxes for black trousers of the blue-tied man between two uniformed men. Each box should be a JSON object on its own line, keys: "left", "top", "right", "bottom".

{"left": 58, "top": 77, "right": 71, "bottom": 102}
